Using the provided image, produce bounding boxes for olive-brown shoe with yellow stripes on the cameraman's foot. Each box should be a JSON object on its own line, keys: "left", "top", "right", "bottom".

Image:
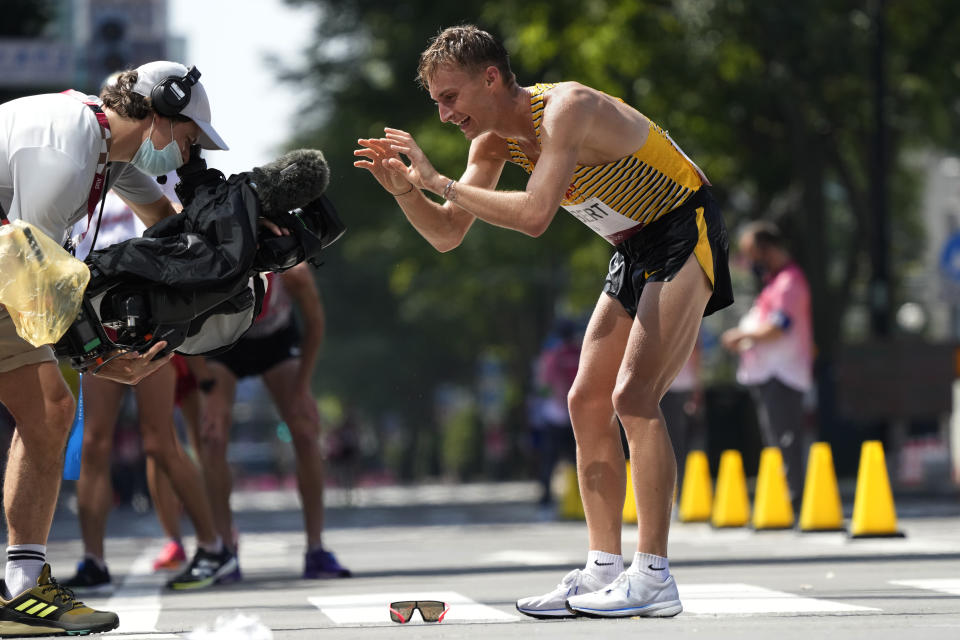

{"left": 0, "top": 564, "right": 120, "bottom": 638}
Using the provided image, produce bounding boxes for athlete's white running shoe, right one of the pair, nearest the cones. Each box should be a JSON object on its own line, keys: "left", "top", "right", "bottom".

{"left": 567, "top": 571, "right": 683, "bottom": 618}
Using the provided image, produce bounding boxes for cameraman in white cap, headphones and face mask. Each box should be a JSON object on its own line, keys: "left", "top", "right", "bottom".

{"left": 0, "top": 62, "right": 227, "bottom": 636}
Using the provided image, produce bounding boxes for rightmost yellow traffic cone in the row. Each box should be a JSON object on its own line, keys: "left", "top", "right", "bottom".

{"left": 850, "top": 440, "right": 903, "bottom": 538}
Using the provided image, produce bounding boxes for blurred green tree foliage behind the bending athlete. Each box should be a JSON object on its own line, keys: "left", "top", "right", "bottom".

{"left": 289, "top": 0, "right": 960, "bottom": 476}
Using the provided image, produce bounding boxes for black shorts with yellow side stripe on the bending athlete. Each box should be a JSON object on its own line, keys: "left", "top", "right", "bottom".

{"left": 603, "top": 187, "right": 733, "bottom": 317}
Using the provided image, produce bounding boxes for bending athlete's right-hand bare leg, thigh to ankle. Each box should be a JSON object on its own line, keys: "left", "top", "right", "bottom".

{"left": 613, "top": 255, "right": 711, "bottom": 557}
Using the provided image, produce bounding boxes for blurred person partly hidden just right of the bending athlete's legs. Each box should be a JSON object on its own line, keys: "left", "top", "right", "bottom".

{"left": 660, "top": 338, "right": 703, "bottom": 491}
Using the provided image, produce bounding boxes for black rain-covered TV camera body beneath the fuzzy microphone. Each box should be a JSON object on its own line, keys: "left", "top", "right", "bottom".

{"left": 55, "top": 145, "right": 346, "bottom": 371}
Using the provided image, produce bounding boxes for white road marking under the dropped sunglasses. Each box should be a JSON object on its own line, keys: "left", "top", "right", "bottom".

{"left": 307, "top": 591, "right": 519, "bottom": 624}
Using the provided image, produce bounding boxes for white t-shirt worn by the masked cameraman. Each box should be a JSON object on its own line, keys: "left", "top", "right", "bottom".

{"left": 0, "top": 93, "right": 163, "bottom": 242}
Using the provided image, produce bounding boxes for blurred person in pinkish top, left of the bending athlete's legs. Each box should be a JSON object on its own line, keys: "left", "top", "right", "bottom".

{"left": 535, "top": 319, "right": 582, "bottom": 504}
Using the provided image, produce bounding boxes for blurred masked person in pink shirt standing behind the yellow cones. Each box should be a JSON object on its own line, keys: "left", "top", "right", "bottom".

{"left": 721, "top": 221, "right": 813, "bottom": 504}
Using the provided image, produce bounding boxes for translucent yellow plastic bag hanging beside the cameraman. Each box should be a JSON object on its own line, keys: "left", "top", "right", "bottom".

{"left": 0, "top": 220, "right": 90, "bottom": 347}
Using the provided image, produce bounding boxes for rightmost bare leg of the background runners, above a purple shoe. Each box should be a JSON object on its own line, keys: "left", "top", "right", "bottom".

{"left": 263, "top": 358, "right": 324, "bottom": 550}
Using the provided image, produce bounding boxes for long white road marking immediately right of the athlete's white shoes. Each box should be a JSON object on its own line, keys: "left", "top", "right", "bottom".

{"left": 677, "top": 583, "right": 879, "bottom": 615}
